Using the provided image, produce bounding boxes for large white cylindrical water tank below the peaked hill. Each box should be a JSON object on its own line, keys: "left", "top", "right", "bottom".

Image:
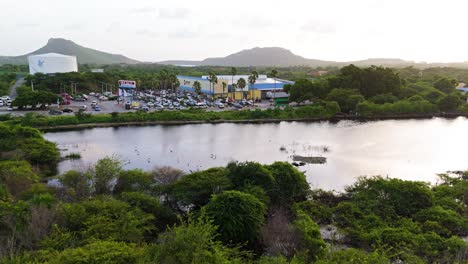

{"left": 28, "top": 53, "right": 78, "bottom": 74}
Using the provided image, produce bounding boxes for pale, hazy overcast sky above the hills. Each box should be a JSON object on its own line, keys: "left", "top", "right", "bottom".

{"left": 0, "top": 0, "right": 468, "bottom": 62}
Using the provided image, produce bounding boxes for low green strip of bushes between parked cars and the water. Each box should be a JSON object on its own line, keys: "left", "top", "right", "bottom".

{"left": 0, "top": 102, "right": 339, "bottom": 128}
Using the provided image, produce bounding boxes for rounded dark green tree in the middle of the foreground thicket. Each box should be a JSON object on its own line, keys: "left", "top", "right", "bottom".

{"left": 203, "top": 191, "right": 266, "bottom": 244}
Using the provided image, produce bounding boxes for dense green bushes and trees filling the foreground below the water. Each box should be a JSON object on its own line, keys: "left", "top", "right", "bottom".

{"left": 0, "top": 124, "right": 468, "bottom": 264}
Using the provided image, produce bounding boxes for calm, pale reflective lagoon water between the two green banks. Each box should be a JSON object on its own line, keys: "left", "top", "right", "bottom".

{"left": 45, "top": 117, "right": 468, "bottom": 190}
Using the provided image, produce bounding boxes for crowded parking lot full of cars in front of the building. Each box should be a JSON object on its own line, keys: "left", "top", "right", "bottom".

{"left": 0, "top": 91, "right": 271, "bottom": 115}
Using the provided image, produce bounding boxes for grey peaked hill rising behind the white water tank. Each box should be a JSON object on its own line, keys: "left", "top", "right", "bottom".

{"left": 0, "top": 38, "right": 140, "bottom": 64}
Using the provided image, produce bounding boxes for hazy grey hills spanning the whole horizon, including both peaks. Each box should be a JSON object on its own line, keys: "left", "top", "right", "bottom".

{"left": 0, "top": 38, "right": 468, "bottom": 68}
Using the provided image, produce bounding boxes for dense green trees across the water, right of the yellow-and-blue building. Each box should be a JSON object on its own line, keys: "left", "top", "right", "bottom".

{"left": 286, "top": 65, "right": 468, "bottom": 116}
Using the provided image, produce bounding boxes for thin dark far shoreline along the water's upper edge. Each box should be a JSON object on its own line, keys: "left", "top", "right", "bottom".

{"left": 36, "top": 113, "right": 468, "bottom": 132}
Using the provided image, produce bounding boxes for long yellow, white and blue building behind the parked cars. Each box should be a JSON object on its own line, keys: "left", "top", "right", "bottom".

{"left": 177, "top": 75, "right": 294, "bottom": 99}
